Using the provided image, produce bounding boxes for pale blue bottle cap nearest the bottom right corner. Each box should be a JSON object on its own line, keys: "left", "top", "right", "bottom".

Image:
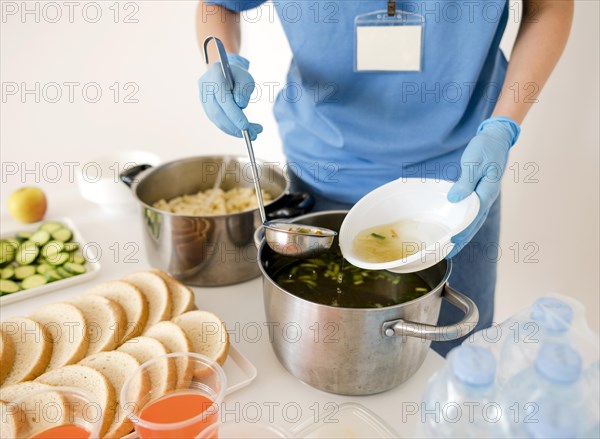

{"left": 535, "top": 342, "right": 581, "bottom": 384}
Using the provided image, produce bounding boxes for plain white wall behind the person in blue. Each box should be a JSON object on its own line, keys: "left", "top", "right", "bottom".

{"left": 0, "top": 1, "right": 600, "bottom": 330}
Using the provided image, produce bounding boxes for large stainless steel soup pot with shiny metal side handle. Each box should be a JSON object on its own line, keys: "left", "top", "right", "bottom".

{"left": 259, "top": 211, "right": 479, "bottom": 395}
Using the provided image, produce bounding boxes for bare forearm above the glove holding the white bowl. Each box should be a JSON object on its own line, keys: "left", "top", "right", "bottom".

{"left": 493, "top": 0, "right": 574, "bottom": 125}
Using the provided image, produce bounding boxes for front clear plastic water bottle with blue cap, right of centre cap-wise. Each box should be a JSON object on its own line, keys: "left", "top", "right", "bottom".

{"left": 503, "top": 342, "right": 589, "bottom": 438}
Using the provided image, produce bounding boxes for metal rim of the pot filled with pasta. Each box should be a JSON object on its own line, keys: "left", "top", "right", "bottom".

{"left": 130, "top": 154, "right": 290, "bottom": 219}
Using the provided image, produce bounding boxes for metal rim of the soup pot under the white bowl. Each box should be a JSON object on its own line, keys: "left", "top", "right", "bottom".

{"left": 257, "top": 210, "right": 452, "bottom": 312}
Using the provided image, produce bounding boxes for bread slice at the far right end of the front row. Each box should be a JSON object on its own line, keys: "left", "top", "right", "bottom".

{"left": 173, "top": 311, "right": 229, "bottom": 365}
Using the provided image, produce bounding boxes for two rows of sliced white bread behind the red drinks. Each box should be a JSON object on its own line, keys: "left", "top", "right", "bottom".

{"left": 0, "top": 269, "right": 229, "bottom": 438}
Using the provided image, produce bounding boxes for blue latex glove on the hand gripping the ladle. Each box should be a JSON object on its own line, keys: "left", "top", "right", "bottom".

{"left": 198, "top": 53, "right": 262, "bottom": 140}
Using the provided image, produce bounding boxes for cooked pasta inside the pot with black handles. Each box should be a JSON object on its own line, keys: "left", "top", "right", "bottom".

{"left": 153, "top": 187, "right": 273, "bottom": 216}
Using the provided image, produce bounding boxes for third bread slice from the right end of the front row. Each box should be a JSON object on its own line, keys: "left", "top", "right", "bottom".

{"left": 117, "top": 336, "right": 177, "bottom": 395}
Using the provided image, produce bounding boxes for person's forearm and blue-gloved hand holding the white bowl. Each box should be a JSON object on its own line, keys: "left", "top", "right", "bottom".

{"left": 448, "top": 0, "right": 573, "bottom": 258}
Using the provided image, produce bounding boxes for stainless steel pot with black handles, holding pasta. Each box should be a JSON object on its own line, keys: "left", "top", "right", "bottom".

{"left": 121, "top": 156, "right": 314, "bottom": 286}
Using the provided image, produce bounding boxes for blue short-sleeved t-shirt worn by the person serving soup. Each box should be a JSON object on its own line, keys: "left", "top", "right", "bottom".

{"left": 209, "top": 0, "right": 508, "bottom": 203}
